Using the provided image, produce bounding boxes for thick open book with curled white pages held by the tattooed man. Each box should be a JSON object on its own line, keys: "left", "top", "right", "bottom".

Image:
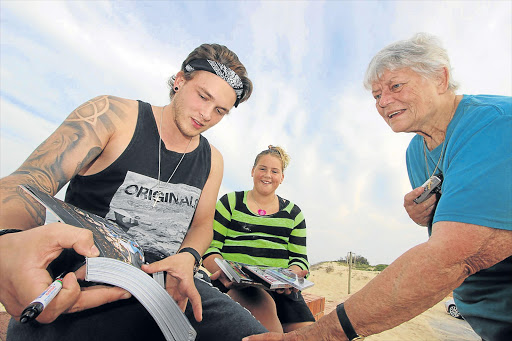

{"left": 20, "top": 185, "right": 196, "bottom": 341}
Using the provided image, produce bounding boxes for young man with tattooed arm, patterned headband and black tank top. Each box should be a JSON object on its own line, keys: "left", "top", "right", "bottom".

{"left": 0, "top": 44, "right": 265, "bottom": 340}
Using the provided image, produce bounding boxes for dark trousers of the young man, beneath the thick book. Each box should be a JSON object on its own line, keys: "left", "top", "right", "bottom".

{"left": 7, "top": 278, "right": 267, "bottom": 341}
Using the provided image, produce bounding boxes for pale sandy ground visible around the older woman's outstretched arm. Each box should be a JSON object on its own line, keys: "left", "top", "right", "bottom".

{"left": 305, "top": 262, "right": 481, "bottom": 341}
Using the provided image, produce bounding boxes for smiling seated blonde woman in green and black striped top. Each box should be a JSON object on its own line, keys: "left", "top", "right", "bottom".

{"left": 203, "top": 146, "right": 315, "bottom": 332}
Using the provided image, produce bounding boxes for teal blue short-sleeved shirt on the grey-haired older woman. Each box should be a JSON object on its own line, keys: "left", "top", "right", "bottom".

{"left": 407, "top": 95, "right": 512, "bottom": 340}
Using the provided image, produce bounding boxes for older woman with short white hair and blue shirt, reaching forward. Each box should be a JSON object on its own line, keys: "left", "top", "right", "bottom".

{"left": 249, "top": 34, "right": 512, "bottom": 341}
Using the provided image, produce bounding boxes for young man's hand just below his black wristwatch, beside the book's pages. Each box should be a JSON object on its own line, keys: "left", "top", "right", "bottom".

{"left": 142, "top": 252, "right": 203, "bottom": 322}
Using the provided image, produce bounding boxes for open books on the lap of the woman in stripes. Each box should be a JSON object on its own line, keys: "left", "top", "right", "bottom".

{"left": 215, "top": 258, "right": 314, "bottom": 290}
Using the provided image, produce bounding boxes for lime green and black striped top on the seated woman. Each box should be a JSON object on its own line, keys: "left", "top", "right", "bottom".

{"left": 204, "top": 191, "right": 309, "bottom": 270}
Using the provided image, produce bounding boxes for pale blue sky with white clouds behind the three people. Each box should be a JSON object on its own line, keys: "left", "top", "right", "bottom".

{"left": 0, "top": 0, "right": 512, "bottom": 264}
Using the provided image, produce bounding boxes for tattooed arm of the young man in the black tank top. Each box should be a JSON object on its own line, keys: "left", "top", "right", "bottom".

{"left": 1, "top": 96, "right": 126, "bottom": 223}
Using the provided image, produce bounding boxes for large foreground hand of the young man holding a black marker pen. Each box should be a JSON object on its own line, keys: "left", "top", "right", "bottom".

{"left": 0, "top": 223, "right": 131, "bottom": 323}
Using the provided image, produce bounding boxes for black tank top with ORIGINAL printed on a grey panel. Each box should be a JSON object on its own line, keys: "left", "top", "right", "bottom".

{"left": 65, "top": 101, "right": 211, "bottom": 256}
